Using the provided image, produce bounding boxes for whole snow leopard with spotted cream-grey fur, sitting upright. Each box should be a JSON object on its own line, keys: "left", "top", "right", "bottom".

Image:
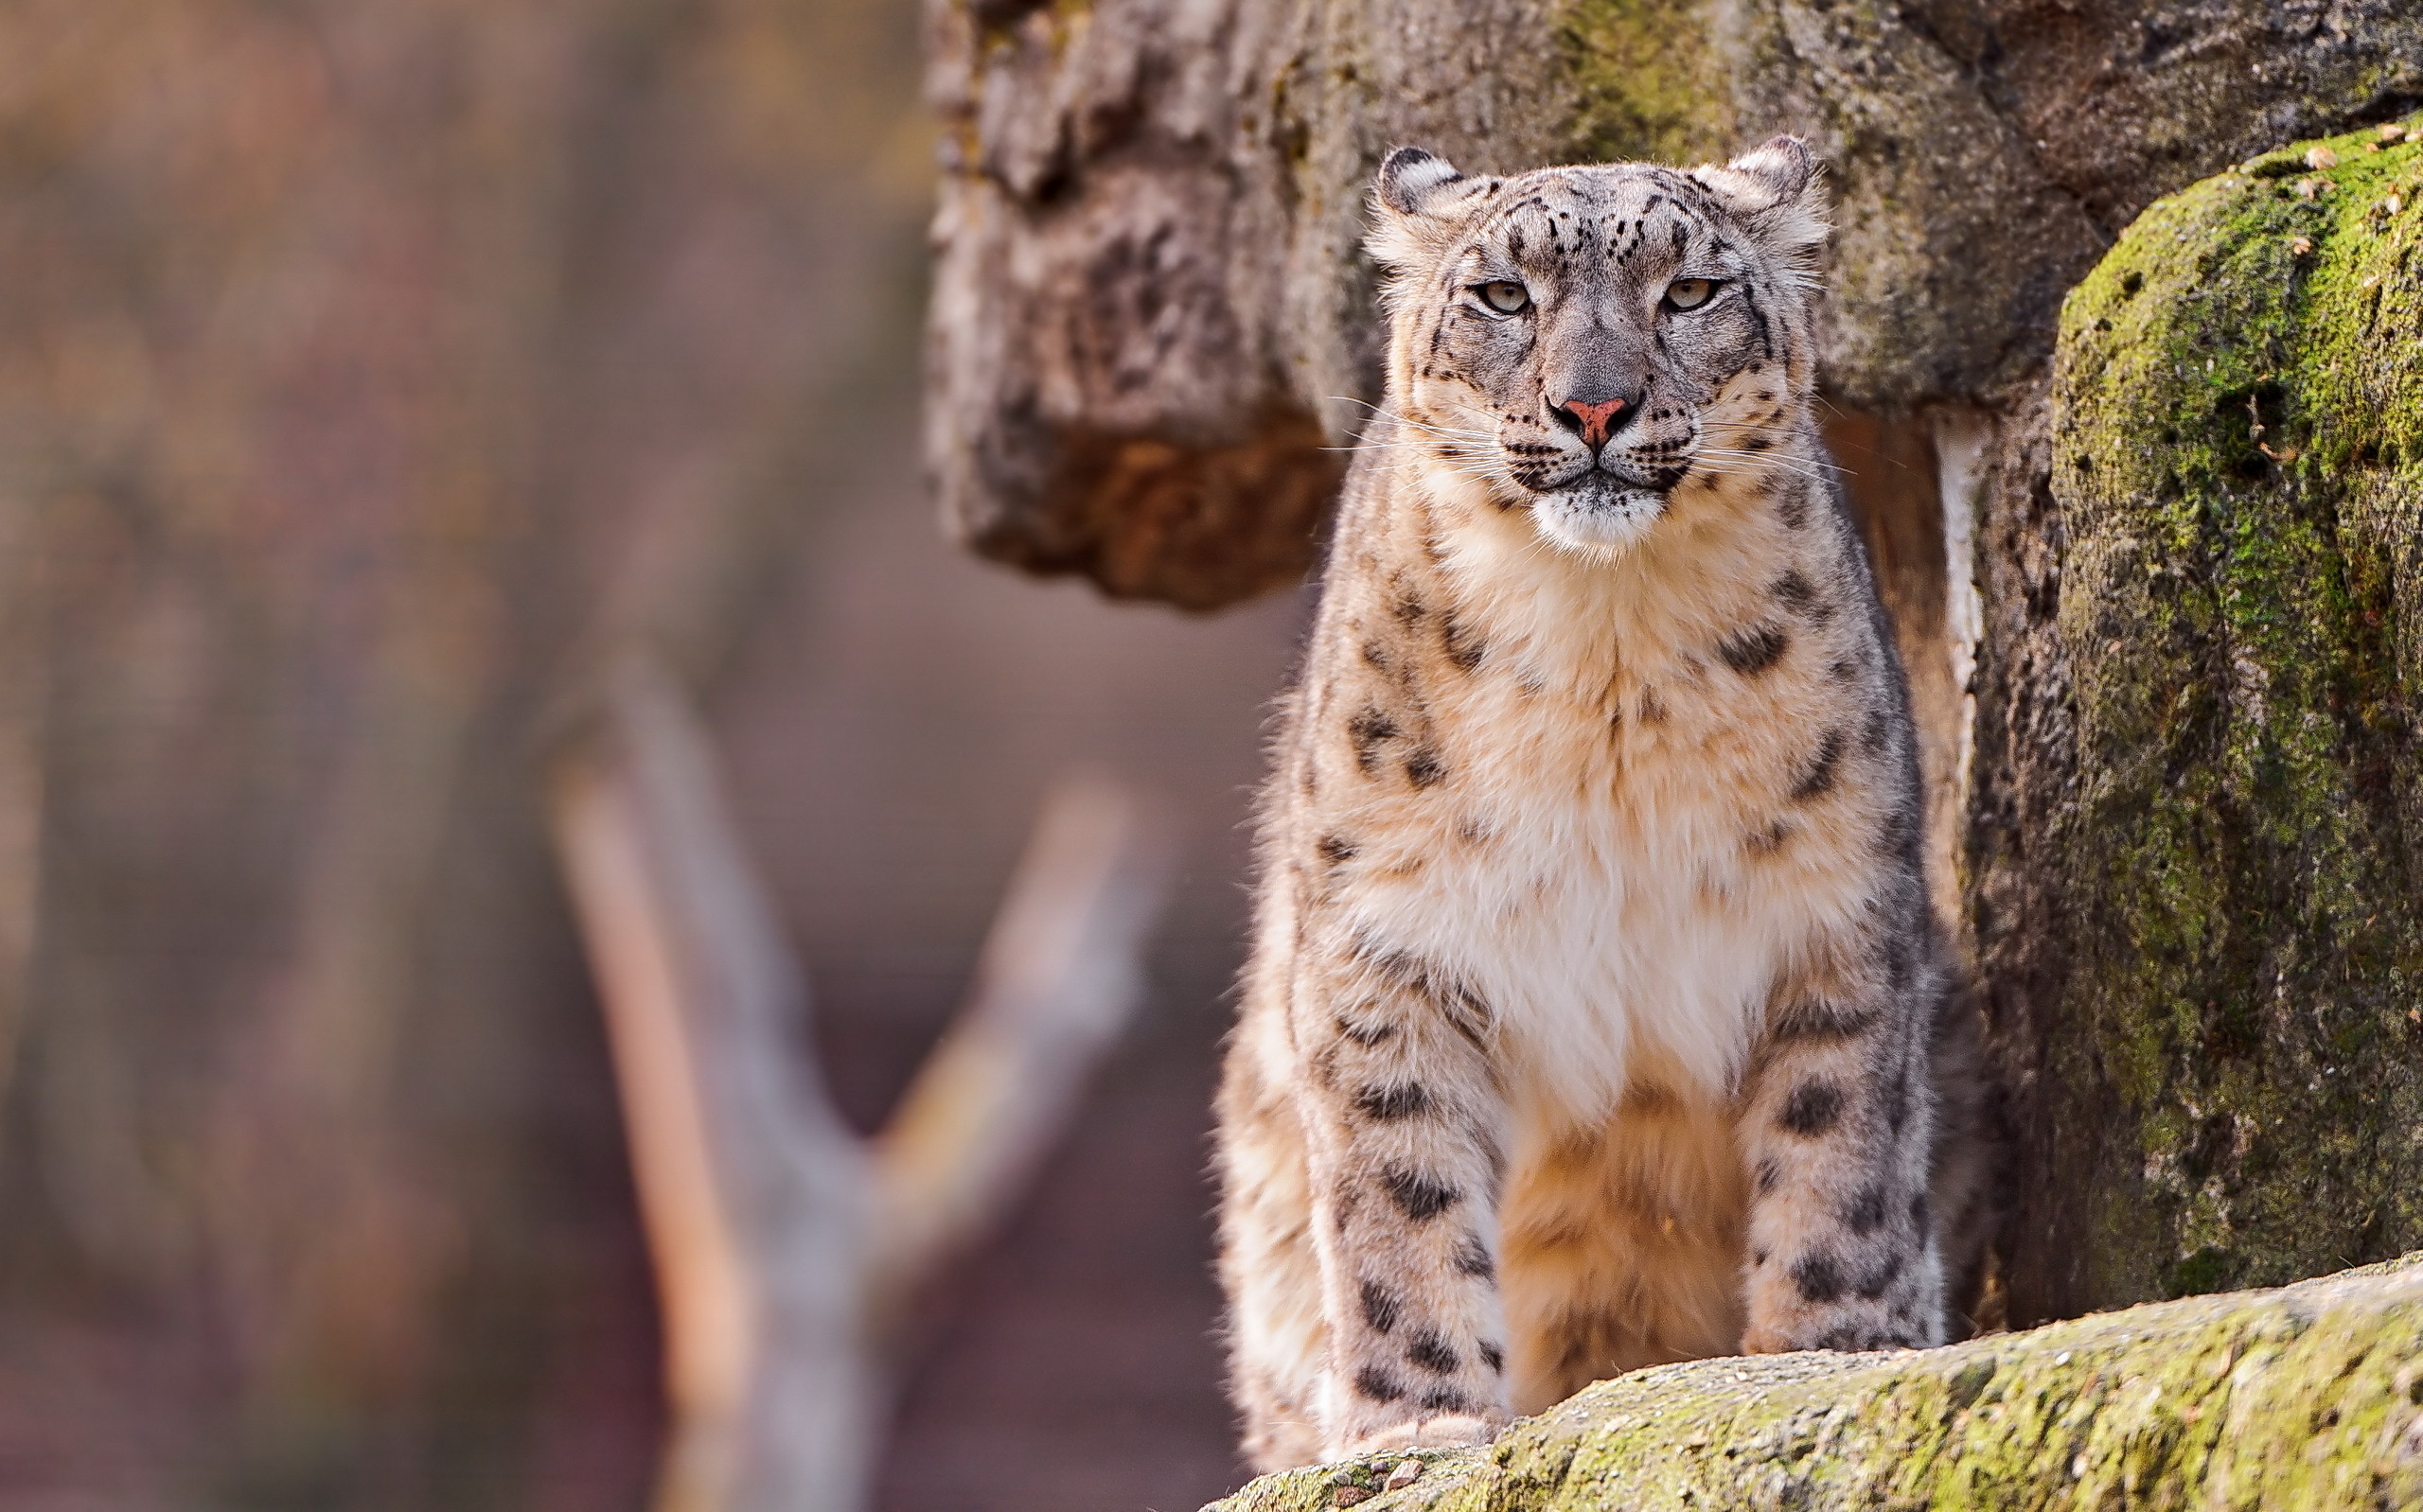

{"left": 1219, "top": 143, "right": 1974, "bottom": 1466}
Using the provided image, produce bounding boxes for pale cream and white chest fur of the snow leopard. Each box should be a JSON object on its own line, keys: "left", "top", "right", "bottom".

{"left": 1340, "top": 467, "right": 1866, "bottom": 1127}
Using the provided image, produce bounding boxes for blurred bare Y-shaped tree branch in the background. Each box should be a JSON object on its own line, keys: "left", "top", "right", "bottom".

{"left": 553, "top": 657, "right": 1163, "bottom": 1512}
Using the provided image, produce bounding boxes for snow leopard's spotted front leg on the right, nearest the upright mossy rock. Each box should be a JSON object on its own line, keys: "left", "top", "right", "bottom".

{"left": 1740, "top": 901, "right": 1948, "bottom": 1355}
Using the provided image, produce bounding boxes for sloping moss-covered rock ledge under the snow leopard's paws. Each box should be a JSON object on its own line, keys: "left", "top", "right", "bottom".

{"left": 1204, "top": 1256, "right": 2423, "bottom": 1512}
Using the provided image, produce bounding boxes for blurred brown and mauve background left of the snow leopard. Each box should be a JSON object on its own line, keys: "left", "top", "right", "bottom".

{"left": 0, "top": 0, "right": 1306, "bottom": 1512}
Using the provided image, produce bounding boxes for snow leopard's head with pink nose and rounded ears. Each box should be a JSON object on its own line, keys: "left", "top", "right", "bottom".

{"left": 1369, "top": 135, "right": 1827, "bottom": 550}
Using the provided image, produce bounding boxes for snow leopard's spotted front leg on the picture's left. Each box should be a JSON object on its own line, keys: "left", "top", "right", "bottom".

{"left": 1291, "top": 936, "right": 1507, "bottom": 1459}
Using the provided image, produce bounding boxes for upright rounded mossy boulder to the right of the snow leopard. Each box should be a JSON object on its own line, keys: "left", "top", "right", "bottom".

{"left": 2041, "top": 114, "right": 2423, "bottom": 1306}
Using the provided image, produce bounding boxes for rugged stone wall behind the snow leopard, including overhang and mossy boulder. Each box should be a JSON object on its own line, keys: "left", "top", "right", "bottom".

{"left": 928, "top": 0, "right": 2423, "bottom": 1321}
